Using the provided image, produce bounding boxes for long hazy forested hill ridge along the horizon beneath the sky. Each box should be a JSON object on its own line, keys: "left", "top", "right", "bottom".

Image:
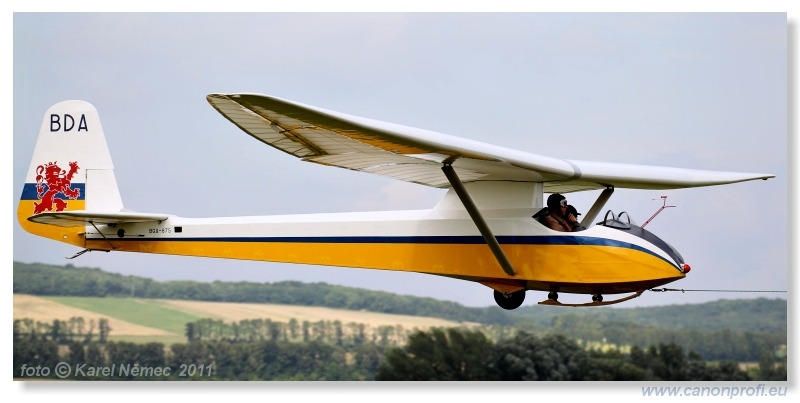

{"left": 14, "top": 262, "right": 787, "bottom": 337}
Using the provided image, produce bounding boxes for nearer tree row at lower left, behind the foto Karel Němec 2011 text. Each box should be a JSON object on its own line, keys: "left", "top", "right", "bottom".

{"left": 13, "top": 339, "right": 383, "bottom": 381}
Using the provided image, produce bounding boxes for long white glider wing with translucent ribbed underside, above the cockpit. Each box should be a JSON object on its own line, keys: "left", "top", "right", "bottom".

{"left": 207, "top": 94, "right": 774, "bottom": 193}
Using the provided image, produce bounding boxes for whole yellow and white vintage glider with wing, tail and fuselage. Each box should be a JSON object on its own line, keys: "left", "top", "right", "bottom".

{"left": 17, "top": 94, "right": 774, "bottom": 309}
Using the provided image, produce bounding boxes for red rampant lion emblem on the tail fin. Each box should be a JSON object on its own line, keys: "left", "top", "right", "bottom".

{"left": 33, "top": 161, "right": 81, "bottom": 214}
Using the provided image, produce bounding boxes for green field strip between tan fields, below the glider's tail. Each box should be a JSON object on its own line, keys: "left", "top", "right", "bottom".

{"left": 45, "top": 297, "right": 203, "bottom": 336}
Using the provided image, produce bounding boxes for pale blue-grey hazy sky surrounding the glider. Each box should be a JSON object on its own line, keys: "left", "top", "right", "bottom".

{"left": 11, "top": 13, "right": 789, "bottom": 307}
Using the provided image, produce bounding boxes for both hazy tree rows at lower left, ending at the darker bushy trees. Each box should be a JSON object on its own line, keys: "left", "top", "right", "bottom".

{"left": 13, "top": 317, "right": 388, "bottom": 380}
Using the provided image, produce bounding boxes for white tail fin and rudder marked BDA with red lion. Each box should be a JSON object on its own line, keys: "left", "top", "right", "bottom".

{"left": 17, "top": 101, "right": 122, "bottom": 246}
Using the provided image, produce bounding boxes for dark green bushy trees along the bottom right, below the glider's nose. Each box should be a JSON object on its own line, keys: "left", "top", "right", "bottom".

{"left": 376, "top": 328, "right": 786, "bottom": 381}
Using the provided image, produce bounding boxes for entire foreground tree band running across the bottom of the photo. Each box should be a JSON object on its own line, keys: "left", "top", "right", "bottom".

{"left": 13, "top": 328, "right": 787, "bottom": 381}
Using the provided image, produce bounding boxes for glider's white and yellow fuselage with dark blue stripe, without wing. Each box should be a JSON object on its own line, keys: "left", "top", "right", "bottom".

{"left": 20, "top": 185, "right": 684, "bottom": 294}
